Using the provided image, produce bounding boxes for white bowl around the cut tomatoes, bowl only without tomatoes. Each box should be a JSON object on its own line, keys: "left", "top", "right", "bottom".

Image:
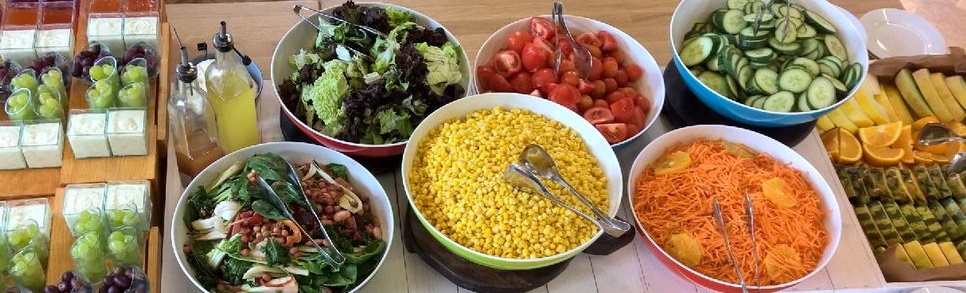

{"left": 473, "top": 15, "right": 664, "bottom": 149}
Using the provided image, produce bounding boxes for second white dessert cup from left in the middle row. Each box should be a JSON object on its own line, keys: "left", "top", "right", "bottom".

{"left": 21, "top": 120, "right": 64, "bottom": 168}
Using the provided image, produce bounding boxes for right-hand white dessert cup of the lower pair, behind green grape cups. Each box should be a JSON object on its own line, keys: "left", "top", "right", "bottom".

{"left": 104, "top": 180, "right": 151, "bottom": 232}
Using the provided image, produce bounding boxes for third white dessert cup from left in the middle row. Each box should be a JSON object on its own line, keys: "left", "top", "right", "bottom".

{"left": 67, "top": 109, "right": 111, "bottom": 159}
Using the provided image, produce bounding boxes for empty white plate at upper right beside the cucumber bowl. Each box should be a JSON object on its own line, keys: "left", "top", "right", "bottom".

{"left": 861, "top": 8, "right": 946, "bottom": 58}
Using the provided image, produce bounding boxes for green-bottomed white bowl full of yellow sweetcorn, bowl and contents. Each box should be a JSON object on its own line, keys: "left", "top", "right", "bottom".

{"left": 402, "top": 93, "right": 623, "bottom": 270}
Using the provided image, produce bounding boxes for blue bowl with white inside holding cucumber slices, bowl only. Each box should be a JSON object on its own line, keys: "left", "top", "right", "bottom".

{"left": 670, "top": 0, "right": 869, "bottom": 127}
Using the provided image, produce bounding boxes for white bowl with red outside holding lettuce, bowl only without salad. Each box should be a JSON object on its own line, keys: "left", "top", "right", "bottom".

{"left": 271, "top": 2, "right": 473, "bottom": 157}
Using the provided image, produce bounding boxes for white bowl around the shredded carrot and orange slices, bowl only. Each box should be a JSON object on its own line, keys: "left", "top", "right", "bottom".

{"left": 627, "top": 125, "right": 842, "bottom": 292}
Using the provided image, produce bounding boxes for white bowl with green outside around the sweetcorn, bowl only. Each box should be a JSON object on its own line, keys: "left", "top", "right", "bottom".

{"left": 402, "top": 93, "right": 624, "bottom": 270}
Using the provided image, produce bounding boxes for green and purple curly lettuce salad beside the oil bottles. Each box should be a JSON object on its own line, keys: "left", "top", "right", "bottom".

{"left": 279, "top": 1, "right": 466, "bottom": 144}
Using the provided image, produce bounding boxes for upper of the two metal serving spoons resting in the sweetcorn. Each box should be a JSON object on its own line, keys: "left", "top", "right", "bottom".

{"left": 520, "top": 144, "right": 631, "bottom": 237}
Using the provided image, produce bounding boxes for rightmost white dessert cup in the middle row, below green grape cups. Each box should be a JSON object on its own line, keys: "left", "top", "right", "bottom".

{"left": 107, "top": 108, "right": 148, "bottom": 156}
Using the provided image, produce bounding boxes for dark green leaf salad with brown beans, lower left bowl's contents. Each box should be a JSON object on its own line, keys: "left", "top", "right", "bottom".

{"left": 182, "top": 153, "right": 386, "bottom": 293}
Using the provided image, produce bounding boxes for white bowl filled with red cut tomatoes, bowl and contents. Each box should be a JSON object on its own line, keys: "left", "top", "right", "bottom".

{"left": 473, "top": 15, "right": 664, "bottom": 149}
